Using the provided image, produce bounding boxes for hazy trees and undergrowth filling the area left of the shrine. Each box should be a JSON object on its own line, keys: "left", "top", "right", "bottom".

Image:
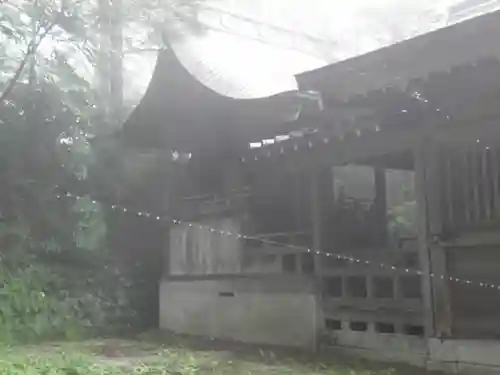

{"left": 0, "top": 0, "right": 199, "bottom": 343}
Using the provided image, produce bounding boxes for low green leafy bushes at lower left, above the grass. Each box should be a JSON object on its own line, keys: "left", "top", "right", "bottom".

{"left": 0, "top": 199, "right": 134, "bottom": 342}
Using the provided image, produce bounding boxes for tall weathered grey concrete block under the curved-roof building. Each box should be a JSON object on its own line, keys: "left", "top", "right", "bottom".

{"left": 160, "top": 279, "right": 318, "bottom": 349}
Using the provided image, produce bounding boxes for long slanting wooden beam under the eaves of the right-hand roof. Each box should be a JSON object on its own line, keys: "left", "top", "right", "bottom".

{"left": 245, "top": 110, "right": 500, "bottom": 169}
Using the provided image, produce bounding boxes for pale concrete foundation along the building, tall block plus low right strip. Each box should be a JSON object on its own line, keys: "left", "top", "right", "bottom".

{"left": 160, "top": 276, "right": 500, "bottom": 375}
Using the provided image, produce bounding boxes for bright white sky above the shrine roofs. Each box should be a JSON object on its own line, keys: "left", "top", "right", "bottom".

{"left": 126, "top": 0, "right": 459, "bottom": 101}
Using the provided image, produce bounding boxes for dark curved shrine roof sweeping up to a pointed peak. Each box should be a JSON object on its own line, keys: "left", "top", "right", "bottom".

{"left": 122, "top": 48, "right": 303, "bottom": 152}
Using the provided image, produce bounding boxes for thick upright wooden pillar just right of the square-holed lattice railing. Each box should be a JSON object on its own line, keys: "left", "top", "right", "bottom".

{"left": 414, "top": 139, "right": 452, "bottom": 337}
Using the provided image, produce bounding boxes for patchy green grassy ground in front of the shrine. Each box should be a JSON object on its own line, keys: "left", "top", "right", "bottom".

{"left": 0, "top": 338, "right": 442, "bottom": 375}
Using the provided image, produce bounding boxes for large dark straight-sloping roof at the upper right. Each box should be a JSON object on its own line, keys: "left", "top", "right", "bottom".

{"left": 296, "top": 11, "right": 500, "bottom": 101}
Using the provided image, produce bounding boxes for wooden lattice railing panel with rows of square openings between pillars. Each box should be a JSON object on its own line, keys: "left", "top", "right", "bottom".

{"left": 322, "top": 268, "right": 423, "bottom": 335}
